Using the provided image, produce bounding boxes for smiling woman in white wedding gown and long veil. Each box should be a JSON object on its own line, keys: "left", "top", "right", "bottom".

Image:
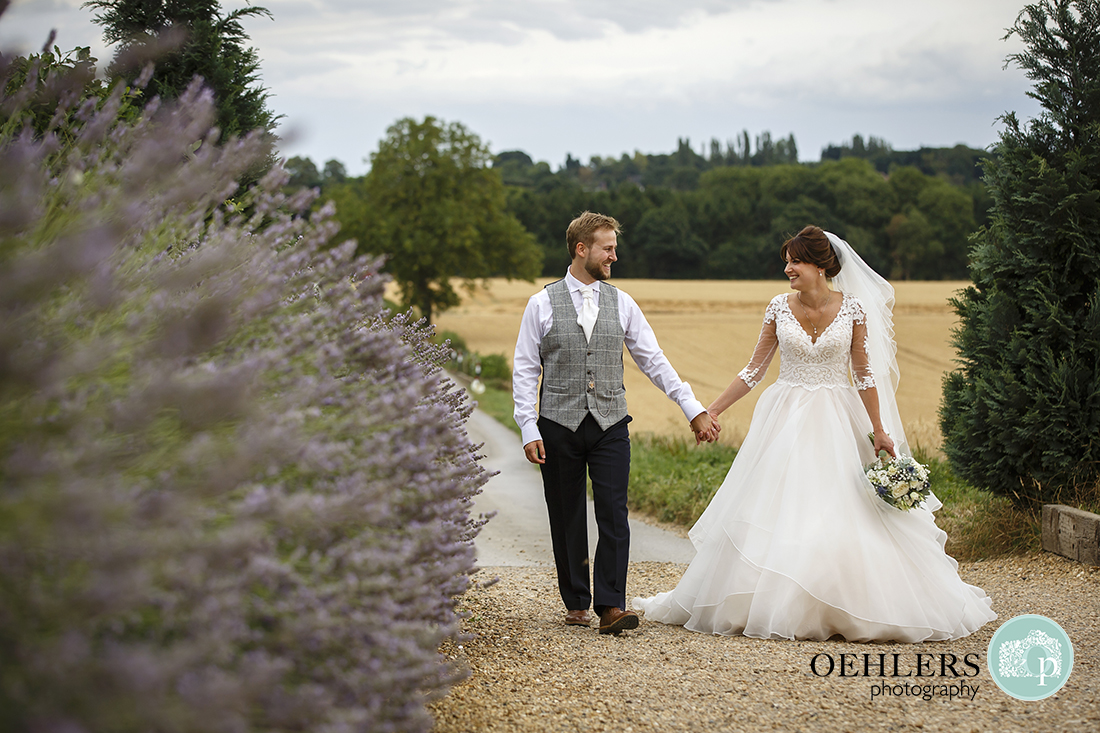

{"left": 634, "top": 227, "right": 997, "bottom": 642}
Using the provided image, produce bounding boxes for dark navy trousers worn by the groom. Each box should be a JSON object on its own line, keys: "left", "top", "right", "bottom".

{"left": 538, "top": 415, "right": 630, "bottom": 613}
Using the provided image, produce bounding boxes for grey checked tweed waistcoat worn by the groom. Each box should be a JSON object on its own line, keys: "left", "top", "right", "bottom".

{"left": 539, "top": 280, "right": 626, "bottom": 430}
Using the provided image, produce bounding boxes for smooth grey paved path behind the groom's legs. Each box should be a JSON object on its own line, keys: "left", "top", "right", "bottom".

{"left": 466, "top": 409, "right": 695, "bottom": 567}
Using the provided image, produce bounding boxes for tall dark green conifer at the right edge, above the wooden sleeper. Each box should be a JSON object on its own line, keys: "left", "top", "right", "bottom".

{"left": 941, "top": 0, "right": 1100, "bottom": 504}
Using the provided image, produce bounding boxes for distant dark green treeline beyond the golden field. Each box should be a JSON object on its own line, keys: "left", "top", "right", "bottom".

{"left": 287, "top": 132, "right": 990, "bottom": 280}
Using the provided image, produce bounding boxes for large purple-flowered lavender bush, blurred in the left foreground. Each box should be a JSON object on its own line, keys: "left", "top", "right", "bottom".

{"left": 0, "top": 41, "right": 486, "bottom": 733}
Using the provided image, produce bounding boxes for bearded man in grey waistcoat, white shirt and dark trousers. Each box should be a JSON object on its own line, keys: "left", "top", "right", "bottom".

{"left": 513, "top": 211, "right": 721, "bottom": 634}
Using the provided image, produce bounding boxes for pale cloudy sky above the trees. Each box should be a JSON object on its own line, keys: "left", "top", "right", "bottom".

{"left": 0, "top": 0, "right": 1037, "bottom": 174}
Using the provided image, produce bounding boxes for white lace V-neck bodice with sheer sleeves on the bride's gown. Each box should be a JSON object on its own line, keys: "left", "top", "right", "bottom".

{"left": 738, "top": 294, "right": 875, "bottom": 390}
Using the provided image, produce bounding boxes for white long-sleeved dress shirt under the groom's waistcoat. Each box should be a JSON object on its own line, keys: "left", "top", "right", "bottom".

{"left": 512, "top": 271, "right": 706, "bottom": 446}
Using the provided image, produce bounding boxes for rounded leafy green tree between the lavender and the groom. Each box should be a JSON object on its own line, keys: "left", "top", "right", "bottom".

{"left": 326, "top": 117, "right": 541, "bottom": 320}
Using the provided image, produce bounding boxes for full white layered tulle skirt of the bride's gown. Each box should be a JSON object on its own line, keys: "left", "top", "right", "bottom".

{"left": 634, "top": 383, "right": 997, "bottom": 643}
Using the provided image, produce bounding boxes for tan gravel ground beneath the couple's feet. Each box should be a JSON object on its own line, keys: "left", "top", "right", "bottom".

{"left": 432, "top": 555, "right": 1100, "bottom": 733}
